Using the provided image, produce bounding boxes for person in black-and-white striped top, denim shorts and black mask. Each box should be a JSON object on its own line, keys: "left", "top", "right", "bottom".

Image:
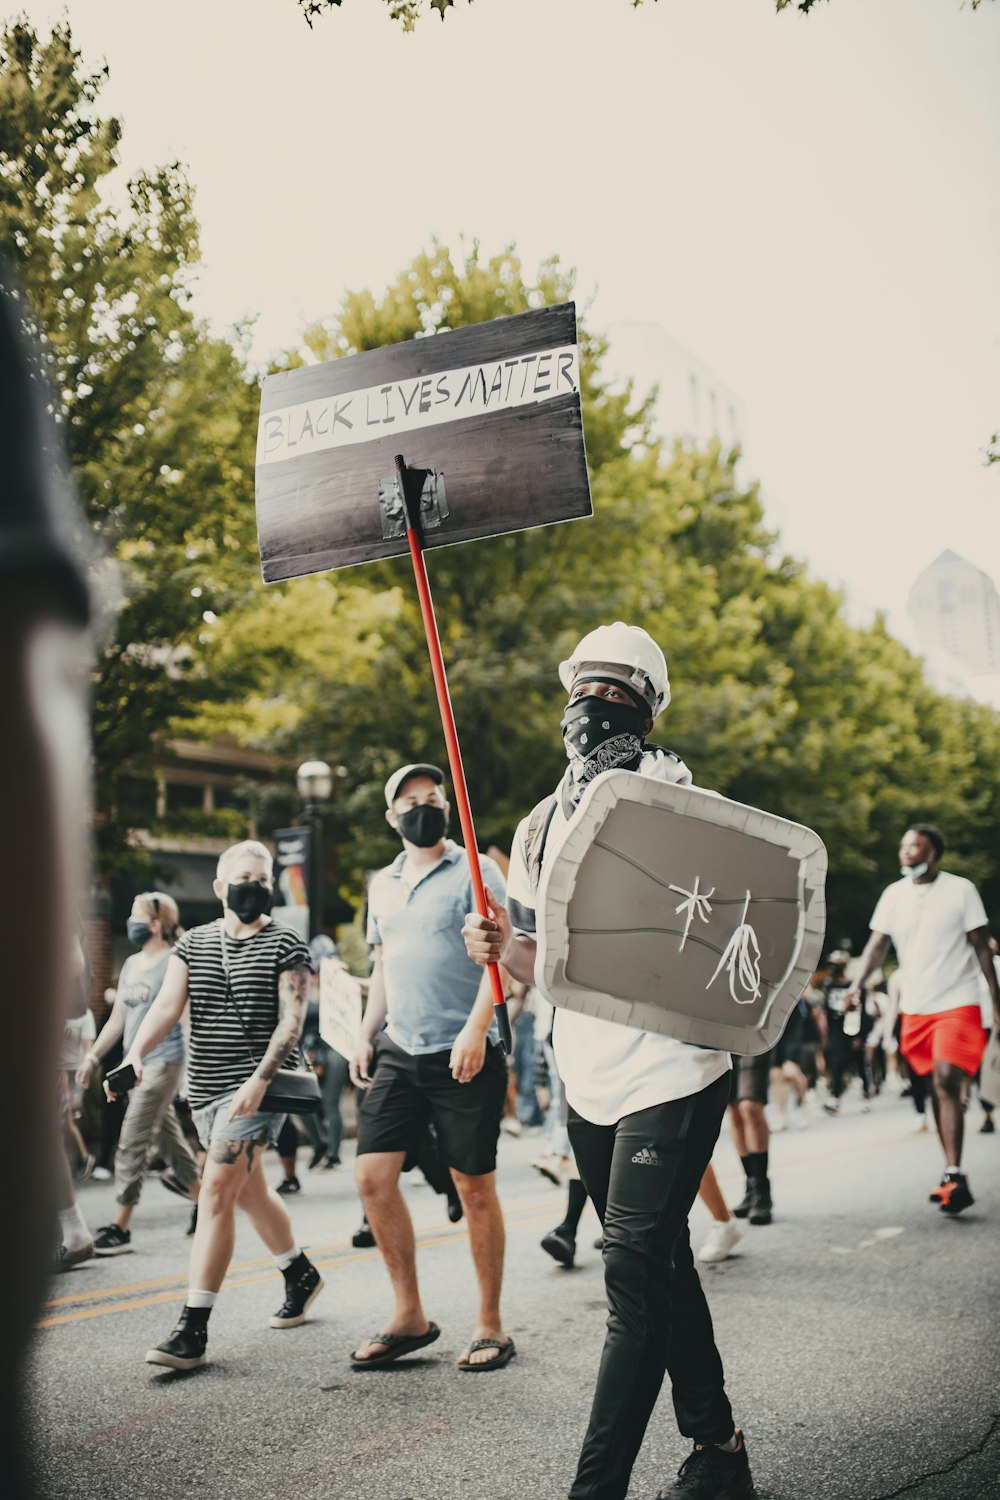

{"left": 124, "top": 840, "right": 322, "bottom": 1370}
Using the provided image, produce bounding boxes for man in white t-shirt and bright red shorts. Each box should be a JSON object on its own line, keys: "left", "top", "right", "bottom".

{"left": 844, "top": 824, "right": 1000, "bottom": 1214}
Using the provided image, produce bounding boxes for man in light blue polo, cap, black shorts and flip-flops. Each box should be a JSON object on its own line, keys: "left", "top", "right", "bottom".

{"left": 351, "top": 765, "right": 514, "bottom": 1373}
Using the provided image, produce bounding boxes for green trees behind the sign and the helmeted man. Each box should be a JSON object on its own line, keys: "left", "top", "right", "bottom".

{"left": 209, "top": 243, "right": 1000, "bottom": 944}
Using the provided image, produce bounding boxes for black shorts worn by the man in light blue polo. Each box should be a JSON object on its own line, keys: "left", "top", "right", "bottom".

{"left": 357, "top": 1034, "right": 507, "bottom": 1178}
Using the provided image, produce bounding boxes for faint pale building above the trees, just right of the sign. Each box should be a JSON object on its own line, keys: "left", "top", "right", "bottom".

{"left": 604, "top": 323, "right": 747, "bottom": 449}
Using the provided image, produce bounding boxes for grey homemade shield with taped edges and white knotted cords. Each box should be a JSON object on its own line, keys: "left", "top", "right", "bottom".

{"left": 535, "top": 771, "right": 826, "bottom": 1056}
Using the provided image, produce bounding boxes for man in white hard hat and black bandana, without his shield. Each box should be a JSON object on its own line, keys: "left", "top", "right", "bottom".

{"left": 463, "top": 621, "right": 753, "bottom": 1500}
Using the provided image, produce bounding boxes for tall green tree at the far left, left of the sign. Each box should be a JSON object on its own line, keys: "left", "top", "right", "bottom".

{"left": 0, "top": 21, "right": 265, "bottom": 867}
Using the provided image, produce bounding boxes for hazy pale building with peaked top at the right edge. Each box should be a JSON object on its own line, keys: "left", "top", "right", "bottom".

{"left": 907, "top": 551, "right": 1000, "bottom": 702}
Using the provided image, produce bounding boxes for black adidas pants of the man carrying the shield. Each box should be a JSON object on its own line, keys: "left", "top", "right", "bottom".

{"left": 570, "top": 1074, "right": 733, "bottom": 1500}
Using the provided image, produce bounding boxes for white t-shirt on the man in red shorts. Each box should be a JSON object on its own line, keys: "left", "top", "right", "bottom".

{"left": 871, "top": 870, "right": 987, "bottom": 1016}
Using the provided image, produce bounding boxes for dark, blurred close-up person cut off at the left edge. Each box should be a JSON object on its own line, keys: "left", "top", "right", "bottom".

{"left": 0, "top": 273, "right": 90, "bottom": 1500}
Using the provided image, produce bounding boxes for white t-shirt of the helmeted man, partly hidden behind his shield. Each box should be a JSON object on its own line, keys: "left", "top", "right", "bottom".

{"left": 507, "top": 750, "right": 732, "bottom": 1125}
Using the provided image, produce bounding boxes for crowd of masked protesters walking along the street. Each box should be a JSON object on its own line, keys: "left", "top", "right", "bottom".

{"left": 57, "top": 623, "right": 1000, "bottom": 1500}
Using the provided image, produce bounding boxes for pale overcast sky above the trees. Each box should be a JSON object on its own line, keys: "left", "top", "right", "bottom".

{"left": 17, "top": 0, "right": 1000, "bottom": 630}
